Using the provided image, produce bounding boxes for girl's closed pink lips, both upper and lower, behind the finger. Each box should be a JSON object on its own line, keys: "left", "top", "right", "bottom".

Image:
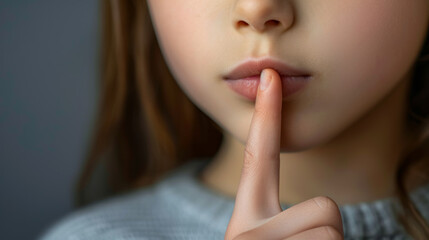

{"left": 223, "top": 58, "right": 312, "bottom": 101}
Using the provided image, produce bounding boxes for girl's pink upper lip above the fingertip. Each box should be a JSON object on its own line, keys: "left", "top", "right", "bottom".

{"left": 223, "top": 58, "right": 310, "bottom": 80}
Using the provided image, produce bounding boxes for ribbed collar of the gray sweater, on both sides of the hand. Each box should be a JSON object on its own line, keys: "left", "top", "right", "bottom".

{"left": 157, "top": 159, "right": 429, "bottom": 239}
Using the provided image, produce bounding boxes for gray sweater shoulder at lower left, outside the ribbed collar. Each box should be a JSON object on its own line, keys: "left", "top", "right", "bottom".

{"left": 40, "top": 187, "right": 166, "bottom": 240}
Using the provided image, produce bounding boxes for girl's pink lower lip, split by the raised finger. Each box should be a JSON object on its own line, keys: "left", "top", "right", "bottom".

{"left": 225, "top": 76, "right": 311, "bottom": 101}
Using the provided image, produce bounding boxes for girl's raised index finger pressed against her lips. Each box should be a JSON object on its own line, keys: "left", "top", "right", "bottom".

{"left": 231, "top": 69, "right": 282, "bottom": 223}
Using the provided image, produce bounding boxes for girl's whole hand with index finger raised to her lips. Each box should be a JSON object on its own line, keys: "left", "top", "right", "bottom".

{"left": 225, "top": 69, "right": 344, "bottom": 240}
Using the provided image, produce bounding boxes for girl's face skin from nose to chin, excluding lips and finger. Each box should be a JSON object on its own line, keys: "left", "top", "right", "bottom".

{"left": 148, "top": 0, "right": 429, "bottom": 150}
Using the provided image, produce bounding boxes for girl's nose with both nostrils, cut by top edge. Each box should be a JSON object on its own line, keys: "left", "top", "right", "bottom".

{"left": 233, "top": 0, "right": 293, "bottom": 32}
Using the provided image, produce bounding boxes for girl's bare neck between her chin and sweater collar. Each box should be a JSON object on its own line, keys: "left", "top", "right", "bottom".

{"left": 201, "top": 71, "right": 422, "bottom": 205}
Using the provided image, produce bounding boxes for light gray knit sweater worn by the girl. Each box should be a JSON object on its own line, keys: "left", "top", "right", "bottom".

{"left": 39, "top": 160, "right": 429, "bottom": 240}
